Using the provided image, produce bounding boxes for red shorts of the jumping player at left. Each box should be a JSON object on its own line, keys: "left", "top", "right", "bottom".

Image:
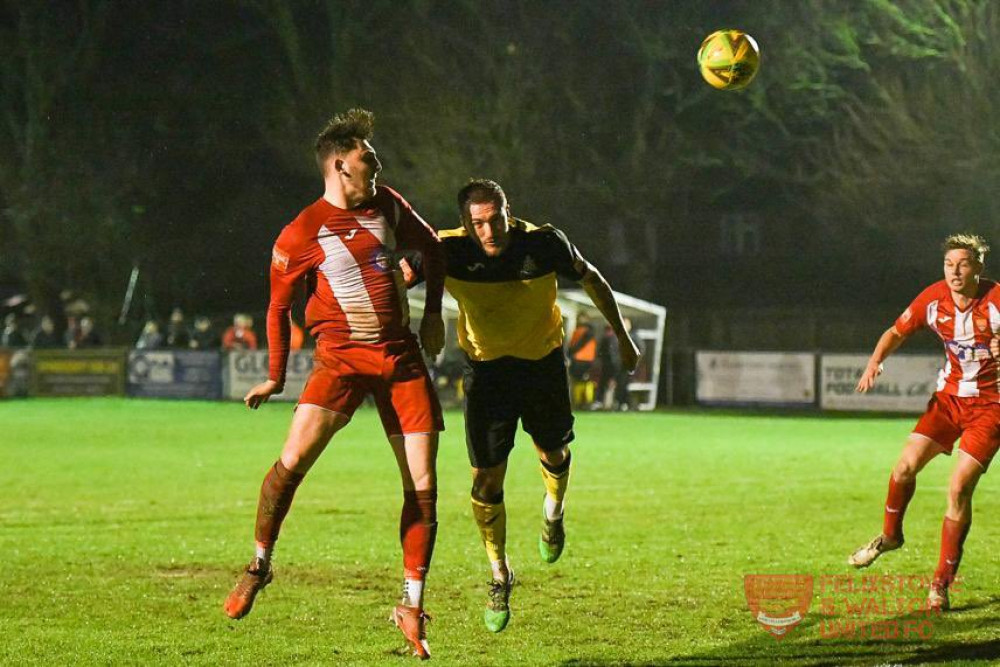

{"left": 299, "top": 336, "right": 444, "bottom": 435}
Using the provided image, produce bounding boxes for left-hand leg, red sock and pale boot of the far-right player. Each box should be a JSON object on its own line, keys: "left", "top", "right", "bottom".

{"left": 847, "top": 433, "right": 945, "bottom": 568}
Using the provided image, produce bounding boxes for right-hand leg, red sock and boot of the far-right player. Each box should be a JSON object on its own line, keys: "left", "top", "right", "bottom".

{"left": 927, "top": 451, "right": 985, "bottom": 611}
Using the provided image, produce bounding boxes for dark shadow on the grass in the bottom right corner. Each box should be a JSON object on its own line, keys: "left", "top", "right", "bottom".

{"left": 561, "top": 596, "right": 1000, "bottom": 667}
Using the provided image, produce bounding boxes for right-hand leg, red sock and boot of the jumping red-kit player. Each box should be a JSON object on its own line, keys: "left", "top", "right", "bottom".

{"left": 389, "top": 433, "right": 438, "bottom": 660}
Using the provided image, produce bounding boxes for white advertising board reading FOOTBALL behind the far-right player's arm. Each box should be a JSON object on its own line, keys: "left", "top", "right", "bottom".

{"left": 819, "top": 354, "right": 944, "bottom": 412}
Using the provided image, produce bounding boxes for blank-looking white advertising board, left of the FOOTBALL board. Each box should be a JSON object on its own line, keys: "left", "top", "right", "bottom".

{"left": 695, "top": 351, "right": 816, "bottom": 405}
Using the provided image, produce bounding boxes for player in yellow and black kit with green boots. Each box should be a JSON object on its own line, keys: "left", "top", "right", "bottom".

{"left": 438, "top": 179, "right": 639, "bottom": 632}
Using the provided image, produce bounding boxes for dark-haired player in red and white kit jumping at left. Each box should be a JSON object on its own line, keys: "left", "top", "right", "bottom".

{"left": 225, "top": 109, "right": 444, "bottom": 658}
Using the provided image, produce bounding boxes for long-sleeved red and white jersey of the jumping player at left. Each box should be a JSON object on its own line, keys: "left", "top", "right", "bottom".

{"left": 267, "top": 186, "right": 444, "bottom": 382}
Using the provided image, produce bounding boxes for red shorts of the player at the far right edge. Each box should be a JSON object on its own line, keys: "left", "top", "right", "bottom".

{"left": 913, "top": 391, "right": 1000, "bottom": 469}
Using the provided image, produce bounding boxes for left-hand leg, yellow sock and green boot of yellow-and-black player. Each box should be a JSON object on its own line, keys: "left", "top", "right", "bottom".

{"left": 472, "top": 461, "right": 514, "bottom": 632}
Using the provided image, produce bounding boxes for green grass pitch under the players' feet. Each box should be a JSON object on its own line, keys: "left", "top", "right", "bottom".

{"left": 0, "top": 399, "right": 1000, "bottom": 665}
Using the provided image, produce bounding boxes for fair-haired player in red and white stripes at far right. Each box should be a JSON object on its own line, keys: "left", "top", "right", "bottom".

{"left": 848, "top": 234, "right": 1000, "bottom": 610}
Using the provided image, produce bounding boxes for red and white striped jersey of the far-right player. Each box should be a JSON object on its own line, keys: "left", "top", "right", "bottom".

{"left": 895, "top": 280, "right": 1000, "bottom": 402}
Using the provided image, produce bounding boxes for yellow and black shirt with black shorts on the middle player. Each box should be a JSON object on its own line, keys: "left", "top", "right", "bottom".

{"left": 439, "top": 218, "right": 586, "bottom": 468}
